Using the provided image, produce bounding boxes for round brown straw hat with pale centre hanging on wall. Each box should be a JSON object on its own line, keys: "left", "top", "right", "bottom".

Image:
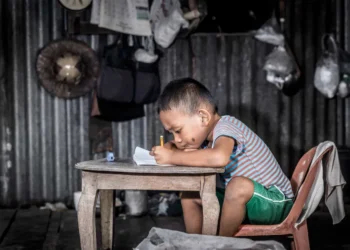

{"left": 36, "top": 39, "right": 100, "bottom": 98}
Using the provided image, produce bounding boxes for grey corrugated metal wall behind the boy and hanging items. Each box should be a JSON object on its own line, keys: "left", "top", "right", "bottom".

{"left": 0, "top": 0, "right": 350, "bottom": 206}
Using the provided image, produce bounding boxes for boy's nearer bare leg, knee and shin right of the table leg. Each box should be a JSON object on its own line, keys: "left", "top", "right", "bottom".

{"left": 219, "top": 177, "right": 254, "bottom": 237}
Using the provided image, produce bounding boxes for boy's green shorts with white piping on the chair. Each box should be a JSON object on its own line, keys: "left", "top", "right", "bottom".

{"left": 216, "top": 180, "right": 293, "bottom": 225}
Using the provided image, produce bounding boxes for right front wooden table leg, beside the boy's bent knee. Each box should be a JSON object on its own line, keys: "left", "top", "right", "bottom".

{"left": 200, "top": 174, "right": 220, "bottom": 235}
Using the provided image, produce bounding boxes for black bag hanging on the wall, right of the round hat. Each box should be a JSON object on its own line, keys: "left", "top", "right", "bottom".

{"left": 97, "top": 36, "right": 160, "bottom": 104}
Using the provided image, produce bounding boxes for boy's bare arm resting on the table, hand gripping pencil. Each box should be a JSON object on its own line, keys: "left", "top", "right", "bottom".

{"left": 152, "top": 136, "right": 234, "bottom": 167}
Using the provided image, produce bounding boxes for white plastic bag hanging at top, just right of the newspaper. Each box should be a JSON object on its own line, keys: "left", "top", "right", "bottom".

{"left": 150, "top": 0, "right": 189, "bottom": 48}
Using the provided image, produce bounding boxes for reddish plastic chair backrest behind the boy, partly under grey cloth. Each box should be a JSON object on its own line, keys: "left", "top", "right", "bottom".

{"left": 282, "top": 147, "right": 332, "bottom": 225}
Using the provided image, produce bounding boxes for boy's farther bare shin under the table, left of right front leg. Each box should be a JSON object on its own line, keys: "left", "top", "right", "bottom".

{"left": 181, "top": 192, "right": 203, "bottom": 234}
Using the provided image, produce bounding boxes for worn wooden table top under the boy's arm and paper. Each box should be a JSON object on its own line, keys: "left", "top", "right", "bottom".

{"left": 75, "top": 158, "right": 225, "bottom": 174}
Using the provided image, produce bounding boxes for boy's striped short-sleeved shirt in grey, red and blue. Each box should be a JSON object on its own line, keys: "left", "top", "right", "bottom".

{"left": 212, "top": 116, "right": 294, "bottom": 198}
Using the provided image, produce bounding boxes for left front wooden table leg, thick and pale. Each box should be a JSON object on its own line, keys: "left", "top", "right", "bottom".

{"left": 78, "top": 171, "right": 97, "bottom": 250}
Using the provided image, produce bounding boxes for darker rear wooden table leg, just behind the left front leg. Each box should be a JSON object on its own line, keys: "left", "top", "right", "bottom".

{"left": 100, "top": 190, "right": 115, "bottom": 250}
